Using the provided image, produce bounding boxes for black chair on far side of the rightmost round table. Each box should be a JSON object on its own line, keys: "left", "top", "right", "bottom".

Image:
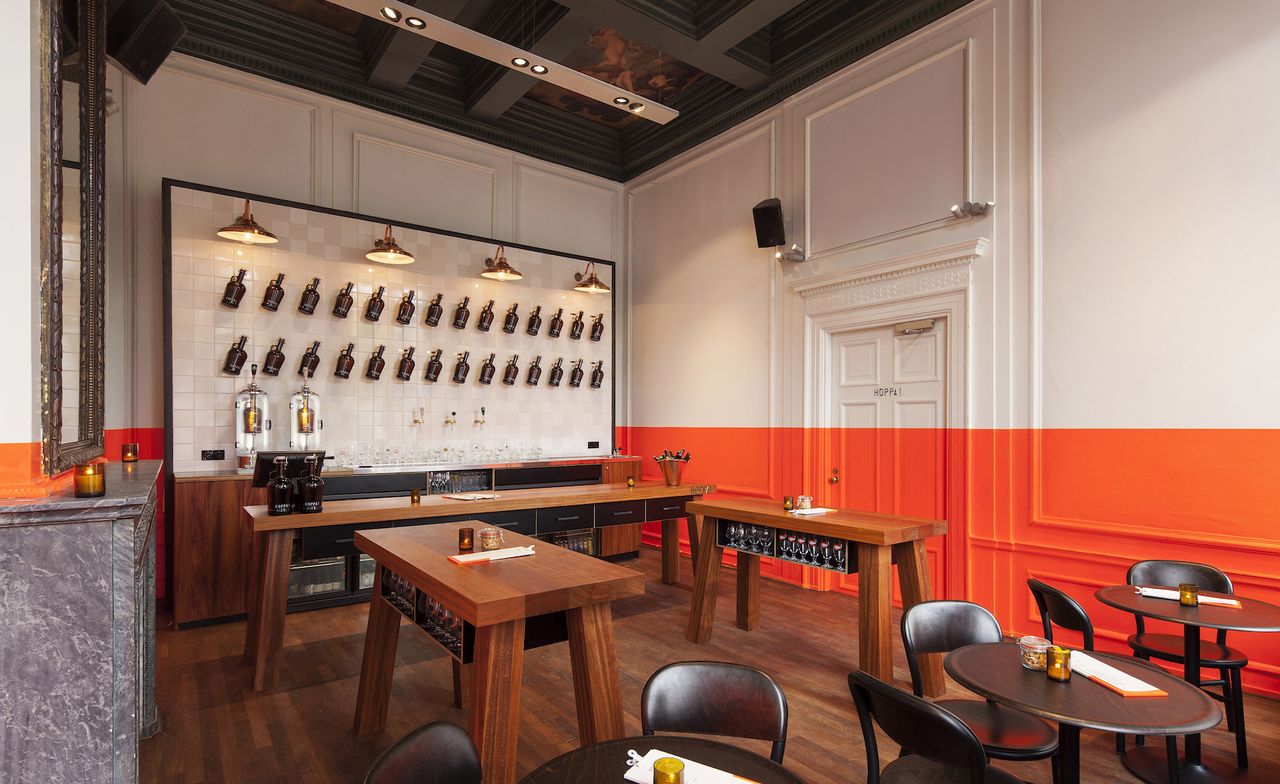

{"left": 1116, "top": 561, "right": 1249, "bottom": 769}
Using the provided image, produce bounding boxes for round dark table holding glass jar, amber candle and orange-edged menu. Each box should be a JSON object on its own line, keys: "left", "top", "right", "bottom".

{"left": 942, "top": 643, "right": 1222, "bottom": 784}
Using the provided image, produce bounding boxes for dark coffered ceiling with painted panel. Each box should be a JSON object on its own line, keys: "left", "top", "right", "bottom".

{"left": 169, "top": 0, "right": 969, "bottom": 181}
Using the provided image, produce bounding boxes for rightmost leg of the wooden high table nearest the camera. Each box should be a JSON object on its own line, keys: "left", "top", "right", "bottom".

{"left": 567, "top": 602, "right": 626, "bottom": 747}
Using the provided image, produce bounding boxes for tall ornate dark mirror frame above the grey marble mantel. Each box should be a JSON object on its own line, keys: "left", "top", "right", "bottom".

{"left": 40, "top": 0, "right": 106, "bottom": 477}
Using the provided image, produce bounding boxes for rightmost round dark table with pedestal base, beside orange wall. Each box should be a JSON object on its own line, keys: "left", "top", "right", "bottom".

{"left": 1093, "top": 585, "right": 1280, "bottom": 784}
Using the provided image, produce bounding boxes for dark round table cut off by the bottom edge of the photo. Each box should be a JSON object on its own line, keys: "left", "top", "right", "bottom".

{"left": 520, "top": 735, "right": 804, "bottom": 784}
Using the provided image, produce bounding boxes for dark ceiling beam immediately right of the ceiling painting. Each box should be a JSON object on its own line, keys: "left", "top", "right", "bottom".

{"left": 557, "top": 0, "right": 769, "bottom": 90}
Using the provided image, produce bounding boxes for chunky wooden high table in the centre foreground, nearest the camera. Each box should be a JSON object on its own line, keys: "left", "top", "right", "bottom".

{"left": 355, "top": 521, "right": 644, "bottom": 784}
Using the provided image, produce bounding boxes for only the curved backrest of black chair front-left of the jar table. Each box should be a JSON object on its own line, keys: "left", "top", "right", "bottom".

{"left": 849, "top": 673, "right": 987, "bottom": 784}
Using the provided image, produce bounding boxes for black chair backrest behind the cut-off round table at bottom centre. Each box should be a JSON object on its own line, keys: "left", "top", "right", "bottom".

{"left": 640, "top": 661, "right": 787, "bottom": 765}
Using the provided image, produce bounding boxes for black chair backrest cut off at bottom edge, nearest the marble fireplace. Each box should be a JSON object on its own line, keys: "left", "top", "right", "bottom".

{"left": 365, "top": 721, "right": 481, "bottom": 784}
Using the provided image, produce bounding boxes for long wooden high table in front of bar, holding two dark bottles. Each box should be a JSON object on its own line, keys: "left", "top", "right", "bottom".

{"left": 244, "top": 482, "right": 716, "bottom": 692}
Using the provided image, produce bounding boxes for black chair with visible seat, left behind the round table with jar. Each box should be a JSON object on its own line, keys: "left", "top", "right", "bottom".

{"left": 902, "top": 600, "right": 1057, "bottom": 780}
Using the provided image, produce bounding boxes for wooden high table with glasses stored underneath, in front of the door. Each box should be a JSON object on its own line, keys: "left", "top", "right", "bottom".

{"left": 685, "top": 498, "right": 947, "bottom": 697}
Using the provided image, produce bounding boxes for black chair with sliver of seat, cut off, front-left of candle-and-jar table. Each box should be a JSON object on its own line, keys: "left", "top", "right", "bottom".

{"left": 849, "top": 673, "right": 1018, "bottom": 784}
